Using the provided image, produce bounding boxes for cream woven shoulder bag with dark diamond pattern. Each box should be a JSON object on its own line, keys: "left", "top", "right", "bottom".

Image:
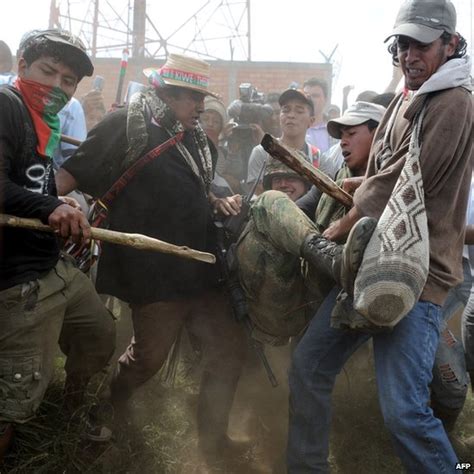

{"left": 354, "top": 99, "right": 429, "bottom": 327}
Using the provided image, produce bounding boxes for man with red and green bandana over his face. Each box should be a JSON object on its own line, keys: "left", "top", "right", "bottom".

{"left": 0, "top": 30, "right": 115, "bottom": 458}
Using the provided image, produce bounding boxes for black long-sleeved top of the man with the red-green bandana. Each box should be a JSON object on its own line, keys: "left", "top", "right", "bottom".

{"left": 0, "top": 86, "right": 62, "bottom": 290}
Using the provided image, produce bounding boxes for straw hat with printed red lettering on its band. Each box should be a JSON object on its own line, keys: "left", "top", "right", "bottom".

{"left": 143, "top": 53, "right": 219, "bottom": 98}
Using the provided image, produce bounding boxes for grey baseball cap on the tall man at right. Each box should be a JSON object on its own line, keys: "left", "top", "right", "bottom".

{"left": 385, "top": 0, "right": 456, "bottom": 44}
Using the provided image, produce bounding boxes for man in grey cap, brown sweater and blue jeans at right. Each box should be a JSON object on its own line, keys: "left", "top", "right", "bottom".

{"left": 288, "top": 0, "right": 472, "bottom": 473}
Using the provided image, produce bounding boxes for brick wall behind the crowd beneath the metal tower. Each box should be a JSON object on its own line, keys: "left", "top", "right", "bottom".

{"left": 76, "top": 58, "right": 332, "bottom": 107}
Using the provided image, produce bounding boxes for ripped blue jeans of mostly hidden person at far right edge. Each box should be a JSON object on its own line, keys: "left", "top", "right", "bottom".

{"left": 431, "top": 258, "right": 474, "bottom": 411}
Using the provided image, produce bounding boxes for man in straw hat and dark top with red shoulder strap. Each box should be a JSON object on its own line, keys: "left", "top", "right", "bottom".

{"left": 56, "top": 54, "right": 246, "bottom": 462}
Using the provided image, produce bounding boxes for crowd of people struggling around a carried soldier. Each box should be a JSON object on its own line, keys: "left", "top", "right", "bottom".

{"left": 0, "top": 0, "right": 474, "bottom": 474}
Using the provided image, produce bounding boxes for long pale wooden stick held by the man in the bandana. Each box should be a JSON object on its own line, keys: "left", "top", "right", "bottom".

{"left": 0, "top": 214, "right": 216, "bottom": 263}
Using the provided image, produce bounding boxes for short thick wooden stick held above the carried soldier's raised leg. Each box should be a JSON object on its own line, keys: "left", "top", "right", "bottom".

{"left": 261, "top": 133, "right": 352, "bottom": 207}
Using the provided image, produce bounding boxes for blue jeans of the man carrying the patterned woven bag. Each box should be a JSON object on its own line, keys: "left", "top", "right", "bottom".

{"left": 287, "top": 288, "right": 457, "bottom": 474}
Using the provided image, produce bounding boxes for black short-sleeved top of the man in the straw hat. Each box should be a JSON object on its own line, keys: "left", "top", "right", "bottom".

{"left": 63, "top": 109, "right": 217, "bottom": 304}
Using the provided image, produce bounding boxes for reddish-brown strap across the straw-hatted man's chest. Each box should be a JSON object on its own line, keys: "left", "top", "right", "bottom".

{"left": 93, "top": 132, "right": 184, "bottom": 226}
